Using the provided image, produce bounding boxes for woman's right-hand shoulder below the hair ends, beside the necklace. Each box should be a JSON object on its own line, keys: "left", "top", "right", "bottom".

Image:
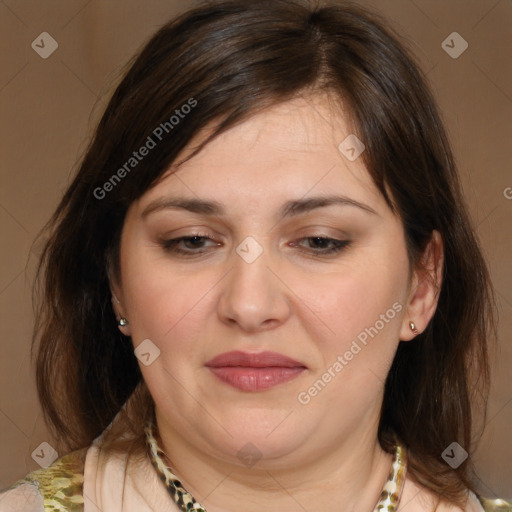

{"left": 398, "top": 478, "right": 512, "bottom": 512}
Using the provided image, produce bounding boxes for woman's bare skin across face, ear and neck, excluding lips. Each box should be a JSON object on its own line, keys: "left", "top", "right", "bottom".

{"left": 112, "top": 96, "right": 452, "bottom": 512}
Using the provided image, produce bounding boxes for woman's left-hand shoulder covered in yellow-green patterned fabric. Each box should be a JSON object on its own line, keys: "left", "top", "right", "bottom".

{"left": 0, "top": 448, "right": 87, "bottom": 512}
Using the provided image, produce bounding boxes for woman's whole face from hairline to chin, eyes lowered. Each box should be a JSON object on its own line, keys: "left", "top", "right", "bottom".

{"left": 115, "top": 98, "right": 418, "bottom": 467}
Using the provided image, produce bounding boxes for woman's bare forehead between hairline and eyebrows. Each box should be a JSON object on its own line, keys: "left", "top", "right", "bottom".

{"left": 137, "top": 97, "right": 386, "bottom": 215}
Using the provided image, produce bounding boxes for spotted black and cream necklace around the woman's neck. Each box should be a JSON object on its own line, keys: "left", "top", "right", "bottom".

{"left": 144, "top": 421, "right": 407, "bottom": 512}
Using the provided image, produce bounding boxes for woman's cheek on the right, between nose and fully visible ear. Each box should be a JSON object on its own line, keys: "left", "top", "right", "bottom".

{"left": 290, "top": 247, "right": 408, "bottom": 396}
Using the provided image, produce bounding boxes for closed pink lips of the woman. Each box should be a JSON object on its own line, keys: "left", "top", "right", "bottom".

{"left": 205, "top": 351, "right": 306, "bottom": 391}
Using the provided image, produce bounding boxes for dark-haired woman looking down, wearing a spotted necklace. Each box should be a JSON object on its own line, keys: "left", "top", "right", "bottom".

{"left": 0, "top": 0, "right": 506, "bottom": 512}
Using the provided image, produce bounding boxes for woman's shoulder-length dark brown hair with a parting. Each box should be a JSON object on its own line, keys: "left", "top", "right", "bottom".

{"left": 33, "top": 0, "right": 496, "bottom": 503}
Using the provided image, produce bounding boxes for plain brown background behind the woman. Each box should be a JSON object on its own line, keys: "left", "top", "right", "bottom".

{"left": 0, "top": 0, "right": 512, "bottom": 499}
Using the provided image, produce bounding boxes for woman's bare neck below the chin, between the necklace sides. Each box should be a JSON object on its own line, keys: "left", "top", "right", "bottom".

{"left": 157, "top": 413, "right": 392, "bottom": 512}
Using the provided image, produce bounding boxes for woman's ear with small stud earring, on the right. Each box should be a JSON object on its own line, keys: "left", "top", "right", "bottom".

{"left": 400, "top": 230, "right": 444, "bottom": 341}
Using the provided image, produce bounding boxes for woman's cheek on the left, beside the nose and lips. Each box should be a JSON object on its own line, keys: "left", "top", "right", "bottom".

{"left": 123, "top": 260, "right": 218, "bottom": 404}
